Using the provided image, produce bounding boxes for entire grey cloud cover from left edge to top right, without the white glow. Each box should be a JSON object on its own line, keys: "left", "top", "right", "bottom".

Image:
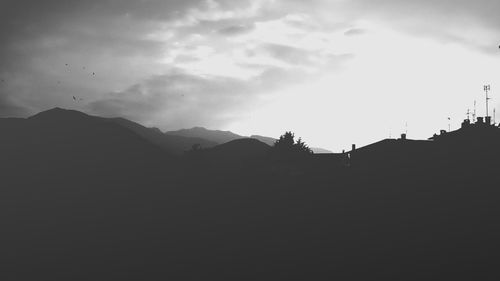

{"left": 0, "top": 0, "right": 500, "bottom": 140}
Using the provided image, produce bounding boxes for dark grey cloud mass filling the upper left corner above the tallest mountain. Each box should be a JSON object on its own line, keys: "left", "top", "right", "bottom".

{"left": 0, "top": 0, "right": 215, "bottom": 115}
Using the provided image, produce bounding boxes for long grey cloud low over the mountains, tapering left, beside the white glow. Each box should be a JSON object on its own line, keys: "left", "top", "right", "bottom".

{"left": 88, "top": 68, "right": 299, "bottom": 129}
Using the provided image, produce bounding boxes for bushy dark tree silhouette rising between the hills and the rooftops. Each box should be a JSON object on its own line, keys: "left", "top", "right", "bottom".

{"left": 271, "top": 132, "right": 313, "bottom": 160}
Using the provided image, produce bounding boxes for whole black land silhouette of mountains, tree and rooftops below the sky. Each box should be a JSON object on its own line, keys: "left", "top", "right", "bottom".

{"left": 0, "top": 104, "right": 500, "bottom": 281}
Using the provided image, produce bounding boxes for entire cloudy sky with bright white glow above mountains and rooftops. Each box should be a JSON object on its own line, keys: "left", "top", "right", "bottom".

{"left": 0, "top": 0, "right": 500, "bottom": 151}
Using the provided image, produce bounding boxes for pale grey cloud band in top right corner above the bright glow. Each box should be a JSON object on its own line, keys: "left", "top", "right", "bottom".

{"left": 344, "top": 0, "right": 500, "bottom": 54}
